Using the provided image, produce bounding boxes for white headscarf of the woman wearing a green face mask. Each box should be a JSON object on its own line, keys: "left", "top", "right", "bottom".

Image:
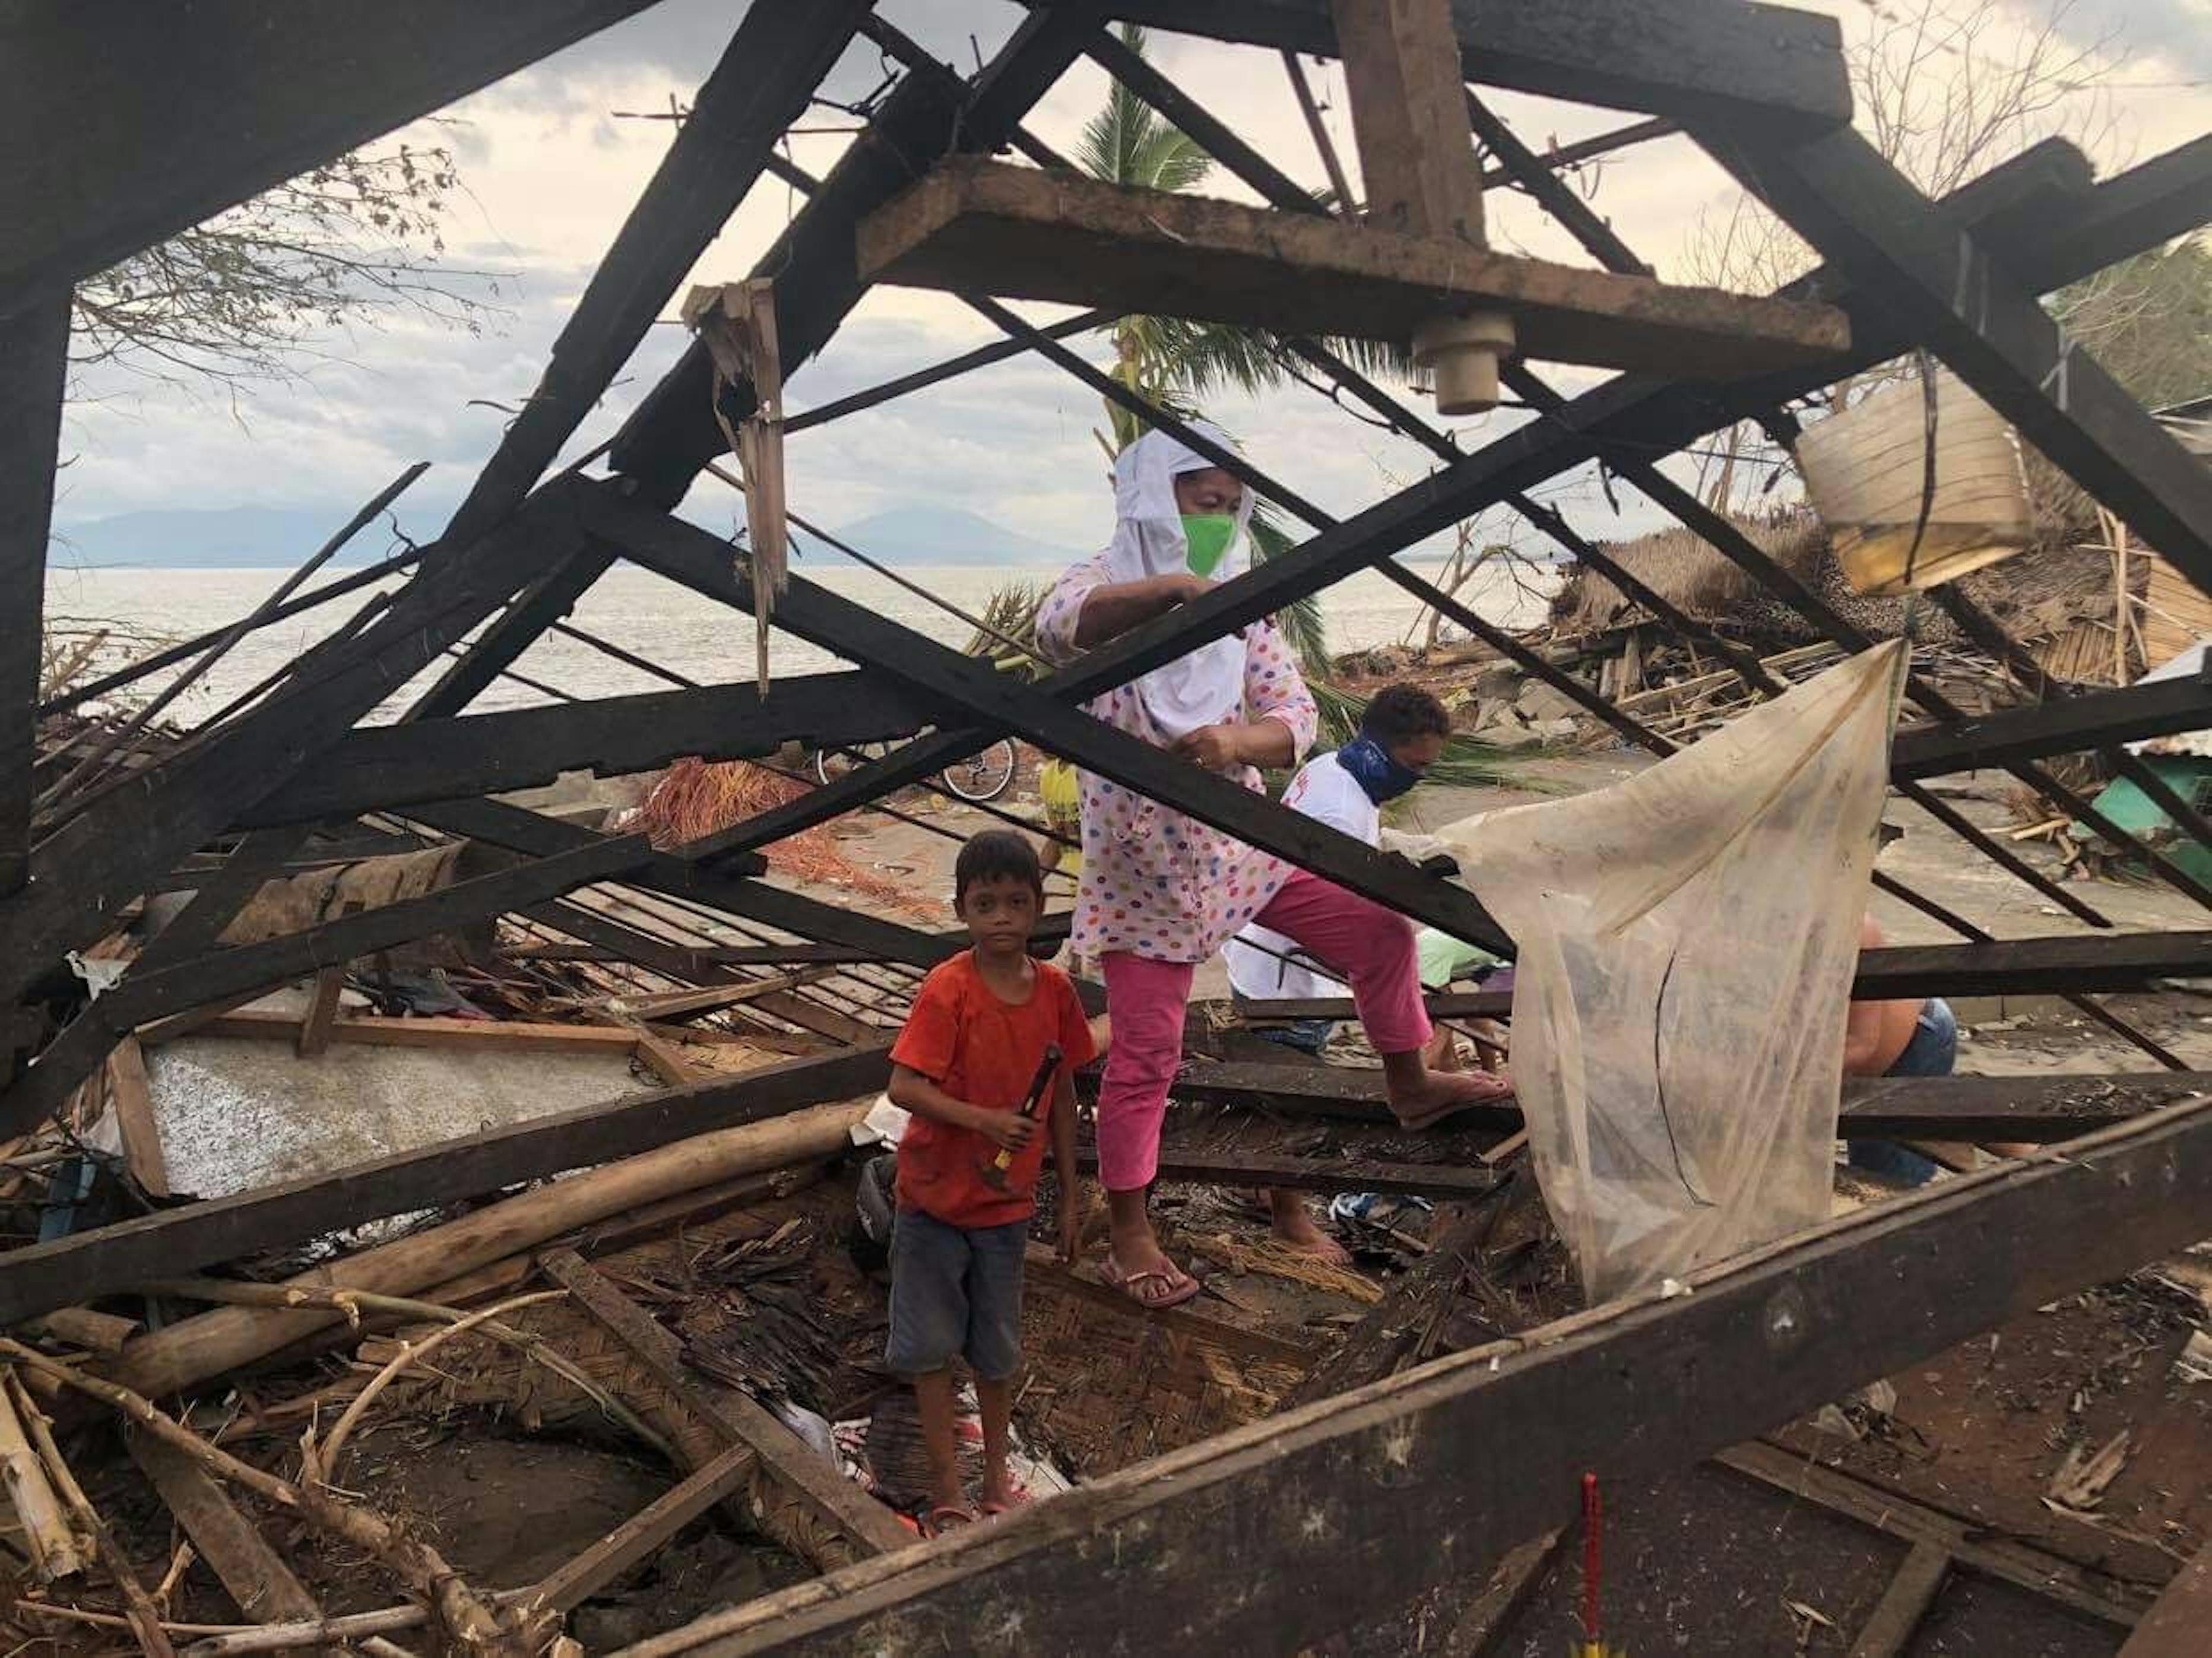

{"left": 1106, "top": 420, "right": 1252, "bottom": 738}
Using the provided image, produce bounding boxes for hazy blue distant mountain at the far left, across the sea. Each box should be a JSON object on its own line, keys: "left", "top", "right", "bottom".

{"left": 53, "top": 502, "right": 451, "bottom": 570}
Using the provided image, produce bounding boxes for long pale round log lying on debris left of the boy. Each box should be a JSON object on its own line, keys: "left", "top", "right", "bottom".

{"left": 104, "top": 1105, "right": 865, "bottom": 1395}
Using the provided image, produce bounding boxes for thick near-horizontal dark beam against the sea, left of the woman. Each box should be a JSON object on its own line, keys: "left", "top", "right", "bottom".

{"left": 239, "top": 672, "right": 936, "bottom": 827}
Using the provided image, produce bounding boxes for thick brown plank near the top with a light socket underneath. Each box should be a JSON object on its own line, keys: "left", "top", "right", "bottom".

{"left": 856, "top": 157, "right": 1852, "bottom": 378}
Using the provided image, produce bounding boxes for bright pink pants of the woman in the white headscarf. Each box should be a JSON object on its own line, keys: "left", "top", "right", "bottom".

{"left": 1099, "top": 869, "right": 1431, "bottom": 1191}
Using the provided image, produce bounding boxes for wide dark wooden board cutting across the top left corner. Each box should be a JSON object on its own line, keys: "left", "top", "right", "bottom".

{"left": 0, "top": 0, "right": 648, "bottom": 312}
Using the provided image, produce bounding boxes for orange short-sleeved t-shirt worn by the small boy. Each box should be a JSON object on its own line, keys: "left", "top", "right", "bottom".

{"left": 892, "top": 950, "right": 1095, "bottom": 1227}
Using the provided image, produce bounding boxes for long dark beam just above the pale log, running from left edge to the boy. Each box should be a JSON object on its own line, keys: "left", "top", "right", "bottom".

{"left": 0, "top": 1048, "right": 892, "bottom": 1324}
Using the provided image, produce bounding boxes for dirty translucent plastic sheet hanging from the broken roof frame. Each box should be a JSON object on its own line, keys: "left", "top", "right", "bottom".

{"left": 1438, "top": 643, "right": 1907, "bottom": 1302}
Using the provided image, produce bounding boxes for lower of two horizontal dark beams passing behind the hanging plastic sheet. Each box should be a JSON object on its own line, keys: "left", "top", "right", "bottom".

{"left": 1159, "top": 1063, "right": 2212, "bottom": 1141}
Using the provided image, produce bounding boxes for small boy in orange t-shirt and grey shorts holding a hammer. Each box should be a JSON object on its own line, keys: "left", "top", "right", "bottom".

{"left": 885, "top": 829, "right": 1093, "bottom": 1534}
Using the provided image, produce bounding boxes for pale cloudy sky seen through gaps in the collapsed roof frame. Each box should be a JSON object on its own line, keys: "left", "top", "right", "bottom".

{"left": 55, "top": 0, "right": 2212, "bottom": 566}
